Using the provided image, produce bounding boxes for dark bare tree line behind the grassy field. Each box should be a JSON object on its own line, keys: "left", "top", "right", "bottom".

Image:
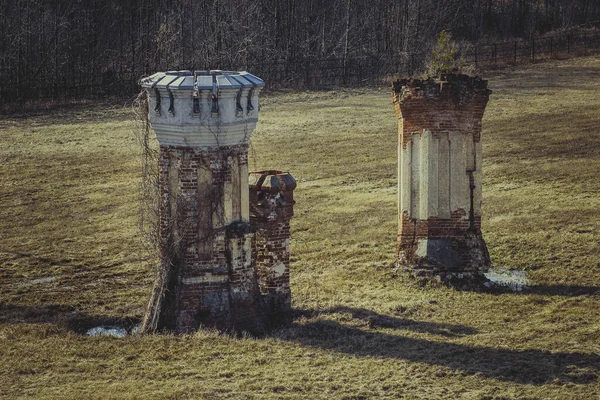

{"left": 0, "top": 0, "right": 600, "bottom": 102}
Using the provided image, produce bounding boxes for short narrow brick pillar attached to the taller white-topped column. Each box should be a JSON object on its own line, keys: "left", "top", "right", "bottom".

{"left": 250, "top": 171, "right": 296, "bottom": 323}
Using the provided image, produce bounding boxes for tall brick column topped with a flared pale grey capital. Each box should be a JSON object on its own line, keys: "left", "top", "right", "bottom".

{"left": 141, "top": 71, "right": 266, "bottom": 333}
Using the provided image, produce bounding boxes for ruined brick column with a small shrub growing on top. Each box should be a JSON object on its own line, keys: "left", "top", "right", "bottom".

{"left": 393, "top": 74, "right": 491, "bottom": 281}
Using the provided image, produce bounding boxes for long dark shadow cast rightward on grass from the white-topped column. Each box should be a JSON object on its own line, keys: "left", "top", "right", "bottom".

{"left": 277, "top": 308, "right": 600, "bottom": 385}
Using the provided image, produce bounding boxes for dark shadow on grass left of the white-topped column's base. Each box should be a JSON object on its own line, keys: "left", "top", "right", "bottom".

{"left": 0, "top": 302, "right": 140, "bottom": 334}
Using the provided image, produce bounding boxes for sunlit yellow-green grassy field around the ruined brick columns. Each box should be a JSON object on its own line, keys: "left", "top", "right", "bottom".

{"left": 0, "top": 57, "right": 600, "bottom": 400}
